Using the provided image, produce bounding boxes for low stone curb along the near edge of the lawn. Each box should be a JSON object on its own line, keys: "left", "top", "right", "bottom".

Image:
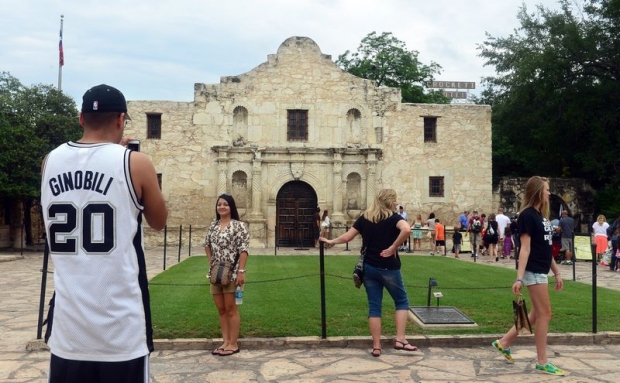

{"left": 26, "top": 331, "right": 620, "bottom": 351}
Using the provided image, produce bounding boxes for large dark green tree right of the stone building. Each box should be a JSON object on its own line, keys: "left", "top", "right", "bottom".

{"left": 478, "top": 0, "right": 620, "bottom": 196}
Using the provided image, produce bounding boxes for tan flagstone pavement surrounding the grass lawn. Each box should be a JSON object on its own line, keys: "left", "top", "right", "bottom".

{"left": 0, "top": 248, "right": 620, "bottom": 383}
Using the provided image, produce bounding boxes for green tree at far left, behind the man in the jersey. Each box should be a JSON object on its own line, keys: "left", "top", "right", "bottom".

{"left": 0, "top": 72, "right": 81, "bottom": 243}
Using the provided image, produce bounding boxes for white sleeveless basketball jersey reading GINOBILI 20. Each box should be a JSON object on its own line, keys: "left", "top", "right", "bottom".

{"left": 41, "top": 142, "right": 153, "bottom": 362}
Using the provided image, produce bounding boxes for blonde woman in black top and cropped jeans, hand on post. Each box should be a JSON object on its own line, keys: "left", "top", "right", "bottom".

{"left": 319, "top": 189, "right": 418, "bottom": 357}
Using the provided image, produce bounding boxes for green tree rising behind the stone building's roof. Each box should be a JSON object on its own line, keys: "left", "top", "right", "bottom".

{"left": 336, "top": 32, "right": 450, "bottom": 104}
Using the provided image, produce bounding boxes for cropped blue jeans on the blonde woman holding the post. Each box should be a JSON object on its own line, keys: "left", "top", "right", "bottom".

{"left": 364, "top": 263, "right": 409, "bottom": 318}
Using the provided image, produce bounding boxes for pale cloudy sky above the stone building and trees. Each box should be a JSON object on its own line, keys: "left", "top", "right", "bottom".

{"left": 0, "top": 0, "right": 559, "bottom": 107}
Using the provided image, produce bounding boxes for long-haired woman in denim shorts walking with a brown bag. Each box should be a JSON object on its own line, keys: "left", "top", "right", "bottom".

{"left": 492, "top": 176, "right": 565, "bottom": 375}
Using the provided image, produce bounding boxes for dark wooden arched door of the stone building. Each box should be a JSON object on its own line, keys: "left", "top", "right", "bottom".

{"left": 276, "top": 181, "right": 317, "bottom": 247}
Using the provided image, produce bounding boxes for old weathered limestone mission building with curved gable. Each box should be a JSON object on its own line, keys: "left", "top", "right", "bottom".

{"left": 125, "top": 37, "right": 493, "bottom": 247}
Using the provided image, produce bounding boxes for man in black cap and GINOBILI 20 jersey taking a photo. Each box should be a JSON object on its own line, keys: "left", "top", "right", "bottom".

{"left": 41, "top": 84, "right": 168, "bottom": 383}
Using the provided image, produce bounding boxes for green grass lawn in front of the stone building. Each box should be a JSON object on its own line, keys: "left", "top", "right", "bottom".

{"left": 150, "top": 255, "right": 620, "bottom": 339}
